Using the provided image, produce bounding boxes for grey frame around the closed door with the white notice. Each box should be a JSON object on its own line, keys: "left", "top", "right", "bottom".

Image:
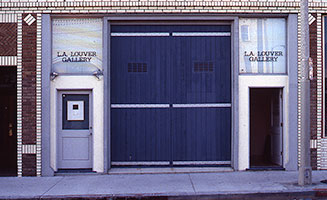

{"left": 56, "top": 90, "right": 94, "bottom": 170}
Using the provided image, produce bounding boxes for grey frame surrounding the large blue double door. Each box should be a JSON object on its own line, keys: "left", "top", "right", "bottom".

{"left": 107, "top": 15, "right": 239, "bottom": 171}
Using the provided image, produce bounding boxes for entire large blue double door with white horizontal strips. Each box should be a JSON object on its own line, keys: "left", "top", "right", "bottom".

{"left": 110, "top": 25, "right": 231, "bottom": 165}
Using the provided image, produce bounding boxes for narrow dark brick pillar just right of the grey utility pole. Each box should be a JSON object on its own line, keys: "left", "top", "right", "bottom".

{"left": 309, "top": 14, "right": 317, "bottom": 170}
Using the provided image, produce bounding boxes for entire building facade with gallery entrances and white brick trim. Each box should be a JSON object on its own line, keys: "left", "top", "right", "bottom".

{"left": 0, "top": 0, "right": 327, "bottom": 176}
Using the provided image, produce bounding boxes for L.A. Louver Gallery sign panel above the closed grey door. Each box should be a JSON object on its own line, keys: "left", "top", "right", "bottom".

{"left": 52, "top": 18, "right": 102, "bottom": 74}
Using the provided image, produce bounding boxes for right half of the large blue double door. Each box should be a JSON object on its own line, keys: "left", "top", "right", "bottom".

{"left": 171, "top": 26, "right": 231, "bottom": 164}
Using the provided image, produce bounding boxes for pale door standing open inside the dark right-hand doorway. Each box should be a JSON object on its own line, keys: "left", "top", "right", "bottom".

{"left": 271, "top": 89, "right": 283, "bottom": 166}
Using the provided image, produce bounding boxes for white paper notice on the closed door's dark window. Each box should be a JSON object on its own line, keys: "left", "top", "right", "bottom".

{"left": 67, "top": 101, "right": 84, "bottom": 121}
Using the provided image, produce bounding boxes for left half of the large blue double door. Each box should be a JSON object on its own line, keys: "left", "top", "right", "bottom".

{"left": 111, "top": 26, "right": 171, "bottom": 165}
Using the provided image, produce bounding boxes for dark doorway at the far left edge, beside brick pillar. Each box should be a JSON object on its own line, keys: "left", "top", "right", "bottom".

{"left": 0, "top": 66, "right": 17, "bottom": 176}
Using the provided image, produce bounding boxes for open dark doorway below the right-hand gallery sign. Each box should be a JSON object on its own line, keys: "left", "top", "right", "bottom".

{"left": 250, "top": 88, "right": 283, "bottom": 169}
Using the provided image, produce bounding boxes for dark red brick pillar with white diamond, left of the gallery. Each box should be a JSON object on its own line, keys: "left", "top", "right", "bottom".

{"left": 22, "top": 14, "right": 37, "bottom": 176}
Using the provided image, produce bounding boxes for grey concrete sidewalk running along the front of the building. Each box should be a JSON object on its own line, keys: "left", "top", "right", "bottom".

{"left": 0, "top": 171, "right": 327, "bottom": 199}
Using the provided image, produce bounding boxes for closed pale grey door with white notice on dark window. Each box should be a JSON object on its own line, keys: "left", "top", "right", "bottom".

{"left": 57, "top": 91, "right": 92, "bottom": 169}
